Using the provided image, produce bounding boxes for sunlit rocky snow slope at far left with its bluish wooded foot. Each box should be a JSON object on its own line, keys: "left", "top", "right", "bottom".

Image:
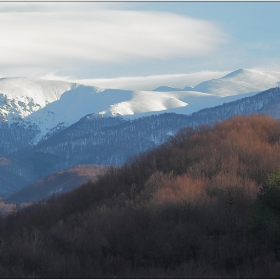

{"left": 0, "top": 78, "right": 78, "bottom": 156}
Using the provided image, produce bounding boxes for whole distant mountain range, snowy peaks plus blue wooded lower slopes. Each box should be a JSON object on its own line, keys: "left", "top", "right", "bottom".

{"left": 0, "top": 69, "right": 280, "bottom": 197}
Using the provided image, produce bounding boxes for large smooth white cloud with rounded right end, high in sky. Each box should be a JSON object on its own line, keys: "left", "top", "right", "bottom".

{"left": 0, "top": 10, "right": 227, "bottom": 72}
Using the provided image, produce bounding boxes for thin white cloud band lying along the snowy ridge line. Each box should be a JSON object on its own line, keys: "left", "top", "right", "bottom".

{"left": 40, "top": 71, "right": 230, "bottom": 90}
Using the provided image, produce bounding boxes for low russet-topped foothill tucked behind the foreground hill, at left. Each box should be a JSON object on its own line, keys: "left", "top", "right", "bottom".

{"left": 4, "top": 165, "right": 104, "bottom": 204}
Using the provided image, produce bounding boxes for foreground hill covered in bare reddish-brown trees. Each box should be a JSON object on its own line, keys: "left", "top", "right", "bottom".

{"left": 0, "top": 115, "right": 280, "bottom": 278}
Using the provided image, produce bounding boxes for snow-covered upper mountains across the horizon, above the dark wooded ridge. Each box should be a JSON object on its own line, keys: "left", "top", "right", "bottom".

{"left": 0, "top": 69, "right": 280, "bottom": 149}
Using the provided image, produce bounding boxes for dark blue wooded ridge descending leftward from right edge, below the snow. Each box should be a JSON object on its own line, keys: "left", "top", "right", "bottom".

{"left": 34, "top": 88, "right": 280, "bottom": 168}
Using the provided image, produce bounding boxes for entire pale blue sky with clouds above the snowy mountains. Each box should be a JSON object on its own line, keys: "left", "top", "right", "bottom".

{"left": 0, "top": 1, "right": 280, "bottom": 90}
